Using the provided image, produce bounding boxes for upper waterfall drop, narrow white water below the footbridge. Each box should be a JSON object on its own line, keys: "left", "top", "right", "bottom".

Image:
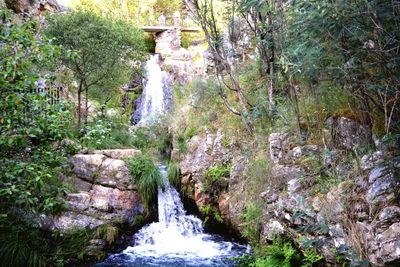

{"left": 133, "top": 54, "right": 172, "bottom": 126}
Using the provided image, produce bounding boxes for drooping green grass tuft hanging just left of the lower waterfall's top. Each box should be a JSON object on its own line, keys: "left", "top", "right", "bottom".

{"left": 126, "top": 155, "right": 164, "bottom": 213}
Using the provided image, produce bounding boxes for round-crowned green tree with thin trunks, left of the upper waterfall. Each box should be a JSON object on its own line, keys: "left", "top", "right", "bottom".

{"left": 45, "top": 11, "right": 144, "bottom": 127}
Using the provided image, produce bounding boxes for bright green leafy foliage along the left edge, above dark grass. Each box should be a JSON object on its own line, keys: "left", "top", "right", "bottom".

{"left": 0, "top": 9, "right": 74, "bottom": 216}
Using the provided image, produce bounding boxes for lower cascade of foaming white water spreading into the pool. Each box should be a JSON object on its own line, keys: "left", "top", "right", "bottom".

{"left": 100, "top": 165, "right": 249, "bottom": 266}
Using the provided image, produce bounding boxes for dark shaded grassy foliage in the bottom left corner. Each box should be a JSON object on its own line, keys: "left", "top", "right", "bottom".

{"left": 0, "top": 214, "right": 90, "bottom": 266}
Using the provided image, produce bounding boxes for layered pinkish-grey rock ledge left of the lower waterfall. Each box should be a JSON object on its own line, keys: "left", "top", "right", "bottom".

{"left": 40, "top": 150, "right": 144, "bottom": 231}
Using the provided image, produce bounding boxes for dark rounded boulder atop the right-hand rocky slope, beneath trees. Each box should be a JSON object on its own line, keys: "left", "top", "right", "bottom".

{"left": 332, "top": 117, "right": 372, "bottom": 149}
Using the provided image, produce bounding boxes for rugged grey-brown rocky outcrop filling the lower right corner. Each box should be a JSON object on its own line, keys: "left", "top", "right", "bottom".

{"left": 260, "top": 131, "right": 400, "bottom": 266}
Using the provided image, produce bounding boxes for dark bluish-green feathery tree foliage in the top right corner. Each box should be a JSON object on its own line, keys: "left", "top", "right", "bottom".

{"left": 285, "top": 0, "right": 400, "bottom": 133}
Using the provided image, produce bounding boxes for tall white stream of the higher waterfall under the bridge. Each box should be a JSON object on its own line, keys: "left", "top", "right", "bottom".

{"left": 138, "top": 55, "right": 167, "bottom": 126}
